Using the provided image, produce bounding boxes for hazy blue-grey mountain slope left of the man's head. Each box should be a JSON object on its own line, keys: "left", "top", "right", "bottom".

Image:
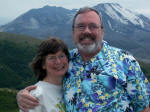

{"left": 0, "top": 6, "right": 75, "bottom": 45}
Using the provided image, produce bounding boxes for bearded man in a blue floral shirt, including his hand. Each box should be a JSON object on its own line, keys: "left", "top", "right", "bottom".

{"left": 18, "top": 7, "right": 150, "bottom": 112}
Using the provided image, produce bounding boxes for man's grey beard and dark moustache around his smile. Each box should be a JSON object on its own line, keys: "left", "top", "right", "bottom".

{"left": 76, "top": 34, "right": 102, "bottom": 54}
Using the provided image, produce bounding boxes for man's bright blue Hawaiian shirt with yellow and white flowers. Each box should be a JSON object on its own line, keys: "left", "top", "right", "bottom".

{"left": 63, "top": 41, "right": 150, "bottom": 112}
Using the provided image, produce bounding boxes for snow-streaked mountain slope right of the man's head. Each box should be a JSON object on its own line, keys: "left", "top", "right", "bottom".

{"left": 94, "top": 3, "right": 150, "bottom": 63}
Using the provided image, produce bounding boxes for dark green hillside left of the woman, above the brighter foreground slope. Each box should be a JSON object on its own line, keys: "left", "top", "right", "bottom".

{"left": 0, "top": 32, "right": 41, "bottom": 89}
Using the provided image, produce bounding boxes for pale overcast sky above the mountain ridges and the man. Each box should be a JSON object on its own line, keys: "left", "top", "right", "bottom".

{"left": 0, "top": 0, "right": 150, "bottom": 19}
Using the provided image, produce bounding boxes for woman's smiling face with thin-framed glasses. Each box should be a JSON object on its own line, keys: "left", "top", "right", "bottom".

{"left": 42, "top": 51, "right": 68, "bottom": 77}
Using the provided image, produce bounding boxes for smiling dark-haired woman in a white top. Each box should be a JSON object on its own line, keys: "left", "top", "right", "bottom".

{"left": 19, "top": 38, "right": 69, "bottom": 112}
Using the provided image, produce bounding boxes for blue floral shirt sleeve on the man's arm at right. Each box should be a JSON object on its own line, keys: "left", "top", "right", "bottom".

{"left": 126, "top": 55, "right": 150, "bottom": 112}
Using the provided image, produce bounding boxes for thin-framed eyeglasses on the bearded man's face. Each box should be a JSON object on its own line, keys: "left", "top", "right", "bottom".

{"left": 75, "top": 24, "right": 100, "bottom": 31}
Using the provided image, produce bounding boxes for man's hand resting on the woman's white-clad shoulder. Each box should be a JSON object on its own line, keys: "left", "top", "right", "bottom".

{"left": 16, "top": 86, "right": 38, "bottom": 112}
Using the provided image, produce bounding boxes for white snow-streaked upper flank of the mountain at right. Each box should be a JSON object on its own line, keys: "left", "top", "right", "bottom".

{"left": 96, "top": 3, "right": 150, "bottom": 28}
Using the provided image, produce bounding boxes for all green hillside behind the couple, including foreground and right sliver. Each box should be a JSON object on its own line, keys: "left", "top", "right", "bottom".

{"left": 0, "top": 32, "right": 150, "bottom": 112}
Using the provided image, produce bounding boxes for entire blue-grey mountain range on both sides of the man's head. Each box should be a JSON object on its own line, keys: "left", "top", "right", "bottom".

{"left": 0, "top": 3, "right": 150, "bottom": 63}
